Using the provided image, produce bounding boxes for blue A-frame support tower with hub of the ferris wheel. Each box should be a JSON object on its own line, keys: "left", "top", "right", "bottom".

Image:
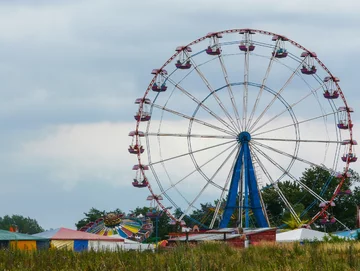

{"left": 220, "top": 132, "right": 269, "bottom": 228}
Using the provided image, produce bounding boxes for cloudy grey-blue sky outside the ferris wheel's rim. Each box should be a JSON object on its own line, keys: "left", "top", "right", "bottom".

{"left": 0, "top": 0, "right": 360, "bottom": 232}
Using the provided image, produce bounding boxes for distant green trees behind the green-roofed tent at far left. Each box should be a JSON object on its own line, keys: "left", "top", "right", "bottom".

{"left": 0, "top": 215, "right": 44, "bottom": 234}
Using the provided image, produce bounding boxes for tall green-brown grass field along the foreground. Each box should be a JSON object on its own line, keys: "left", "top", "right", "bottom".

{"left": 0, "top": 242, "right": 360, "bottom": 271}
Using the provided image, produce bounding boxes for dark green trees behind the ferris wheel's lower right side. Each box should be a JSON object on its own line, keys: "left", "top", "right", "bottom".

{"left": 262, "top": 167, "right": 360, "bottom": 232}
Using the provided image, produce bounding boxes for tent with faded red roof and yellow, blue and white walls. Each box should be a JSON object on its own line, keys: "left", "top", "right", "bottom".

{"left": 34, "top": 228, "right": 124, "bottom": 251}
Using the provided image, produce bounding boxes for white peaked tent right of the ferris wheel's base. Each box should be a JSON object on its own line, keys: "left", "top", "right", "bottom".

{"left": 276, "top": 229, "right": 329, "bottom": 242}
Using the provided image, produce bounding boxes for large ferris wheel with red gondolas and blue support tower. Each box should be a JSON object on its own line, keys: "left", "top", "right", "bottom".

{"left": 129, "top": 29, "right": 357, "bottom": 228}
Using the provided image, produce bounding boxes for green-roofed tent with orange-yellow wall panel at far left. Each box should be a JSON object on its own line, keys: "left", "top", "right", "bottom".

{"left": 0, "top": 230, "right": 49, "bottom": 250}
